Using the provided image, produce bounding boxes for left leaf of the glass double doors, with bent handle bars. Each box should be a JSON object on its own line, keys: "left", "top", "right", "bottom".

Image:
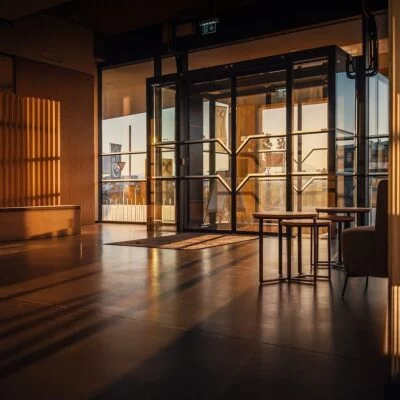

{"left": 181, "top": 79, "right": 232, "bottom": 231}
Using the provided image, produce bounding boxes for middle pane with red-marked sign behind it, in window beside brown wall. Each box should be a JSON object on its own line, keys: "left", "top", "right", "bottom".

{"left": 102, "top": 153, "right": 146, "bottom": 180}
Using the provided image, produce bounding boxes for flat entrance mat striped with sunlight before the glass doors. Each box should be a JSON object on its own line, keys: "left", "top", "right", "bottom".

{"left": 107, "top": 233, "right": 257, "bottom": 250}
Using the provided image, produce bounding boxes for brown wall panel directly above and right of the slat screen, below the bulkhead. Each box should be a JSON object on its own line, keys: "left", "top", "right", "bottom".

{"left": 16, "top": 57, "right": 95, "bottom": 225}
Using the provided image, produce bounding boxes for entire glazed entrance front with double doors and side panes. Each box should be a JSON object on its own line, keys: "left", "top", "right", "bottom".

{"left": 147, "top": 50, "right": 336, "bottom": 232}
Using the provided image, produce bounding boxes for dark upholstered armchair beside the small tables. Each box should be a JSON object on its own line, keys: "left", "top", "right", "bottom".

{"left": 342, "top": 180, "right": 388, "bottom": 296}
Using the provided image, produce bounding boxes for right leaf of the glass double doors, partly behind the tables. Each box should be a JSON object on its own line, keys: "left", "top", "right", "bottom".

{"left": 236, "top": 70, "right": 287, "bottom": 231}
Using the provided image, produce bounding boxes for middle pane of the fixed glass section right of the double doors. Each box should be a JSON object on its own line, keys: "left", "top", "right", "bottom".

{"left": 292, "top": 133, "right": 328, "bottom": 174}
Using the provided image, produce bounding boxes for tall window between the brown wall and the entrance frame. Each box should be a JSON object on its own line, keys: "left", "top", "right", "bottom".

{"left": 101, "top": 62, "right": 154, "bottom": 222}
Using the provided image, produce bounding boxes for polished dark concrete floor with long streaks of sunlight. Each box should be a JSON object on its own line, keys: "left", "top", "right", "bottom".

{"left": 0, "top": 224, "right": 388, "bottom": 400}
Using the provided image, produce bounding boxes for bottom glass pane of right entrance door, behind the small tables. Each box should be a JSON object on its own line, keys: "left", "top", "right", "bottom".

{"left": 236, "top": 177, "right": 286, "bottom": 232}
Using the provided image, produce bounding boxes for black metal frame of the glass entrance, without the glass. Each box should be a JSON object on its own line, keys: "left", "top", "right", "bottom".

{"left": 146, "top": 46, "right": 341, "bottom": 233}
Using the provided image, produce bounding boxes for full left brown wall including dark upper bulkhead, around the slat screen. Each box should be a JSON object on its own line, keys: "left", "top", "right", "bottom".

{"left": 0, "top": 13, "right": 97, "bottom": 224}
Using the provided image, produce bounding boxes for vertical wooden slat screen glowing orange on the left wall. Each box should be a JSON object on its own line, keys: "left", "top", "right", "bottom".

{"left": 0, "top": 93, "right": 60, "bottom": 207}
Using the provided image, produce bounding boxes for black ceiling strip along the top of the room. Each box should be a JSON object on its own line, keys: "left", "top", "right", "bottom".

{"left": 46, "top": 0, "right": 387, "bottom": 36}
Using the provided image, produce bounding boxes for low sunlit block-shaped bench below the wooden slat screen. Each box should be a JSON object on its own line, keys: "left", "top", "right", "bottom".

{"left": 0, "top": 205, "right": 81, "bottom": 242}
